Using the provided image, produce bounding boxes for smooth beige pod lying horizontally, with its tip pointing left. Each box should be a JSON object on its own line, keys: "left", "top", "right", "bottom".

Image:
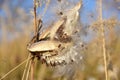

{"left": 27, "top": 41, "right": 60, "bottom": 52}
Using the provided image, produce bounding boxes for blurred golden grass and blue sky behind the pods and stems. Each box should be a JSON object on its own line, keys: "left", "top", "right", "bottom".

{"left": 0, "top": 0, "right": 120, "bottom": 80}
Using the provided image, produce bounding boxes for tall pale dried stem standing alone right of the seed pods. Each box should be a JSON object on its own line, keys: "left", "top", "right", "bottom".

{"left": 99, "top": 0, "right": 108, "bottom": 80}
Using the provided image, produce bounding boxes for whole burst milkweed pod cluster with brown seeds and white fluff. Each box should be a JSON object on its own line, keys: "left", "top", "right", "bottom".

{"left": 27, "top": 3, "right": 81, "bottom": 66}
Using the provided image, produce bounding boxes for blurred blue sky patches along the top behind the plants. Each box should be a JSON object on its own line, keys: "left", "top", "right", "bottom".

{"left": 0, "top": 0, "right": 120, "bottom": 42}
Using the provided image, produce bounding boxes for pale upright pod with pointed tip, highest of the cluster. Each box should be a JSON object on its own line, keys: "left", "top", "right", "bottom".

{"left": 64, "top": 3, "right": 81, "bottom": 35}
